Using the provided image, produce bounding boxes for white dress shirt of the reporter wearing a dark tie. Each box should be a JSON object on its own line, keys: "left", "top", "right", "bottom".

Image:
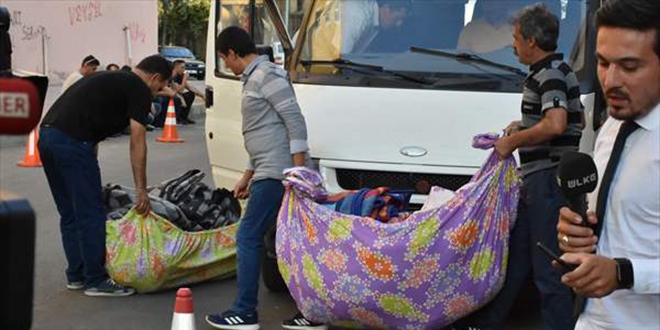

{"left": 575, "top": 105, "right": 660, "bottom": 330}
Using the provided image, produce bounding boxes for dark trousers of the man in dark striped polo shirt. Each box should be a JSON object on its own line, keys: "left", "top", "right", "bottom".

{"left": 455, "top": 168, "right": 575, "bottom": 330}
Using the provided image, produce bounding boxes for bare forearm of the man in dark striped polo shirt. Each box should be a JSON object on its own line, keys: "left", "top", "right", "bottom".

{"left": 495, "top": 108, "right": 567, "bottom": 158}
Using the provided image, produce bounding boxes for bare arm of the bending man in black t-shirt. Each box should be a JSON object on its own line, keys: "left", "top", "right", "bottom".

{"left": 130, "top": 119, "right": 151, "bottom": 215}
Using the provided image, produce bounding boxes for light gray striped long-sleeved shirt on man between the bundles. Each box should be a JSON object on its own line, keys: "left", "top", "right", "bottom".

{"left": 241, "top": 56, "right": 311, "bottom": 181}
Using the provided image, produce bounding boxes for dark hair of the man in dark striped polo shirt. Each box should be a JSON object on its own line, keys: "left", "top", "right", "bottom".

{"left": 513, "top": 3, "right": 559, "bottom": 52}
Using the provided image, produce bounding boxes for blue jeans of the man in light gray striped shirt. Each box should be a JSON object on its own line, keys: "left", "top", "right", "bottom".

{"left": 231, "top": 179, "right": 284, "bottom": 314}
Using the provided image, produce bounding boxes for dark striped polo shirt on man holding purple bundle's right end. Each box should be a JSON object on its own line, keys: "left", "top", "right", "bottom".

{"left": 518, "top": 54, "right": 583, "bottom": 176}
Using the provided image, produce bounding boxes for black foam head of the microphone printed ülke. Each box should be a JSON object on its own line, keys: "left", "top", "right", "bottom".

{"left": 557, "top": 151, "right": 598, "bottom": 198}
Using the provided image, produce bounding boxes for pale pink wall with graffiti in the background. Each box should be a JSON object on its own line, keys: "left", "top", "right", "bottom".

{"left": 0, "top": 0, "right": 158, "bottom": 84}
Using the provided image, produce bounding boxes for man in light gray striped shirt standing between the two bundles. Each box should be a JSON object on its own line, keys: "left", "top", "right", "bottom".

{"left": 206, "top": 27, "right": 326, "bottom": 330}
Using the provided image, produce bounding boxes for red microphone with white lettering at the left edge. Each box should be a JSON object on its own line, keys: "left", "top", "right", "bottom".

{"left": 0, "top": 78, "right": 42, "bottom": 135}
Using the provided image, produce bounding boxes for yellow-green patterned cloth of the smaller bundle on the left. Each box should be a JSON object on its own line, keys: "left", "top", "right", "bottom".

{"left": 106, "top": 210, "right": 238, "bottom": 293}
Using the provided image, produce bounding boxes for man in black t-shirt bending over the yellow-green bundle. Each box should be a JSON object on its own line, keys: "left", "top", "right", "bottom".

{"left": 39, "top": 55, "right": 172, "bottom": 296}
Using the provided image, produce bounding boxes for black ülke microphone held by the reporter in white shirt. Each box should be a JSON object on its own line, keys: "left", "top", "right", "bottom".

{"left": 557, "top": 151, "right": 598, "bottom": 227}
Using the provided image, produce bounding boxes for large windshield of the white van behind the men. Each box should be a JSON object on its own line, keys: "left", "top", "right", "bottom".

{"left": 297, "top": 0, "right": 587, "bottom": 92}
